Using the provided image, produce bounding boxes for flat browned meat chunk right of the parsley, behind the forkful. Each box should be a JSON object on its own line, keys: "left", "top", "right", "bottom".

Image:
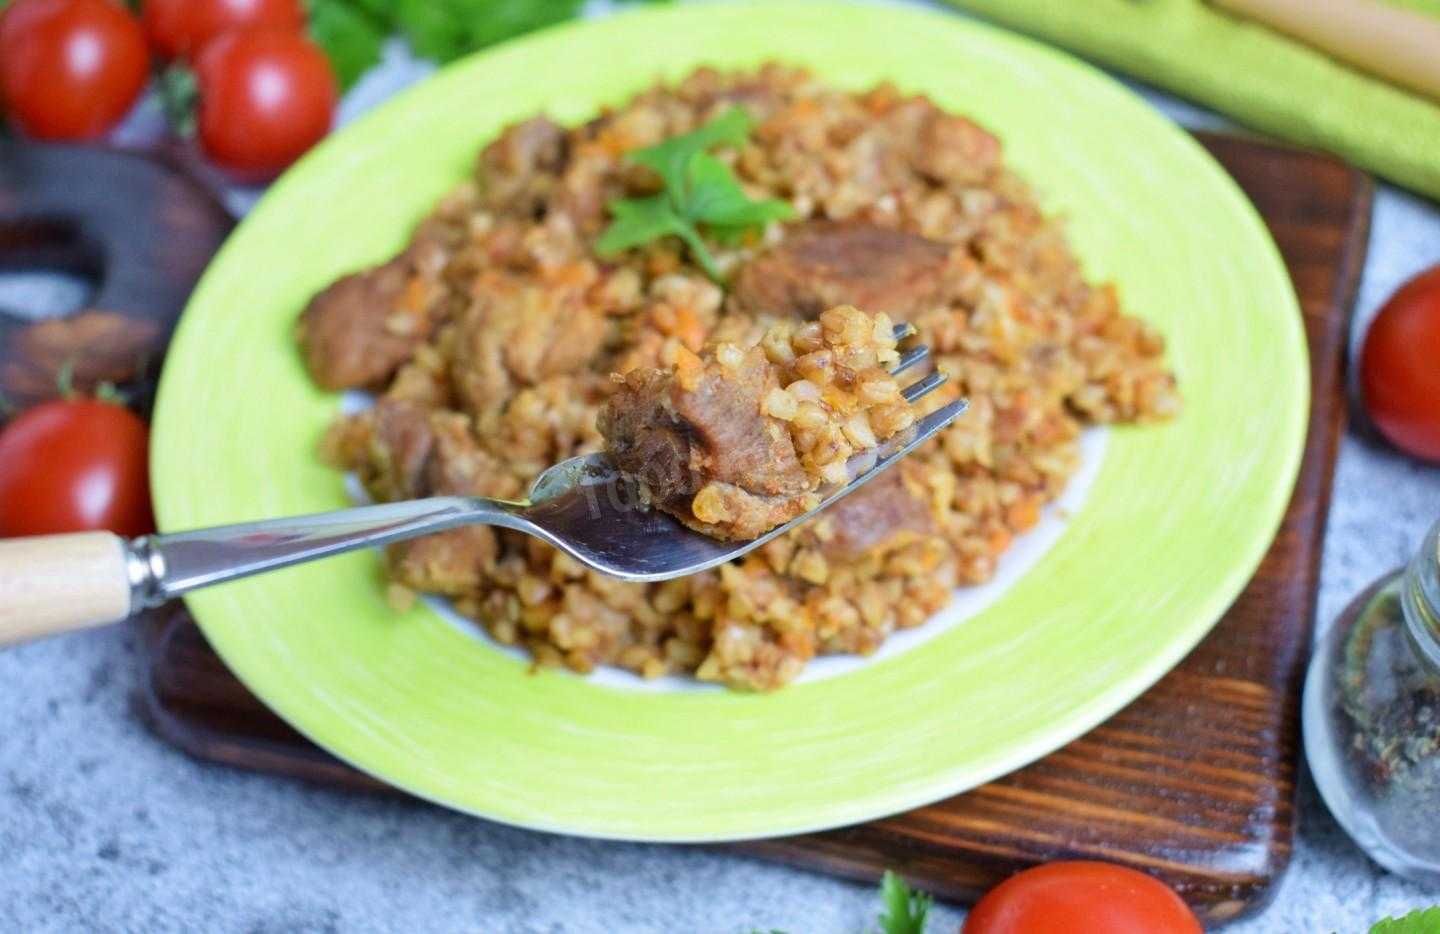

{"left": 732, "top": 223, "right": 950, "bottom": 321}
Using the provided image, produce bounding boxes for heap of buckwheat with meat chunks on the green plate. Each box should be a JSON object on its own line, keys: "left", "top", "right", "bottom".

{"left": 301, "top": 65, "right": 1178, "bottom": 689}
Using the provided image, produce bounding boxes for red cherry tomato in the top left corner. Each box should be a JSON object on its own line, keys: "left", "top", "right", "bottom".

{"left": 0, "top": 0, "right": 150, "bottom": 140}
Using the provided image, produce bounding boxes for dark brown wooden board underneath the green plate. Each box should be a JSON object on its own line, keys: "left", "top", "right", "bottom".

{"left": 126, "top": 135, "right": 1371, "bottom": 922}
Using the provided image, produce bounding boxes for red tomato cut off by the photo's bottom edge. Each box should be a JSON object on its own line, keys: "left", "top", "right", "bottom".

{"left": 960, "top": 861, "right": 1202, "bottom": 934}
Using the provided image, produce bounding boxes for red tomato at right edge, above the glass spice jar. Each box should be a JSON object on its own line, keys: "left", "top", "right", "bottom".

{"left": 1359, "top": 266, "right": 1440, "bottom": 462}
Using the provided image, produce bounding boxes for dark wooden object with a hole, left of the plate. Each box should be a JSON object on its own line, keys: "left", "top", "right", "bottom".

{"left": 0, "top": 138, "right": 233, "bottom": 406}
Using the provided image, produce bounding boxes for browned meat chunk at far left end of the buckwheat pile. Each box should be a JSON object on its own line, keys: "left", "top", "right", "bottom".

{"left": 300, "top": 237, "right": 444, "bottom": 390}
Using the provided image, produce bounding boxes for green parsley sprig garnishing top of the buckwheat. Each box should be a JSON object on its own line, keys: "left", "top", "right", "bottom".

{"left": 595, "top": 106, "right": 795, "bottom": 282}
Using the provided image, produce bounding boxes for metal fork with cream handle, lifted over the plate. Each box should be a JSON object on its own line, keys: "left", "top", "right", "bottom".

{"left": 0, "top": 325, "right": 968, "bottom": 645}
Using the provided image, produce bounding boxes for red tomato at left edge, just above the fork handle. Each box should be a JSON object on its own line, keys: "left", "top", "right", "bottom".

{"left": 0, "top": 399, "right": 154, "bottom": 537}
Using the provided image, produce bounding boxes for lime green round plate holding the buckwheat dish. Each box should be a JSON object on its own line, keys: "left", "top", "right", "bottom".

{"left": 153, "top": 1, "right": 1309, "bottom": 840}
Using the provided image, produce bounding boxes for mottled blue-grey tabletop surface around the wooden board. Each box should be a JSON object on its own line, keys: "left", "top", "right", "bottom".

{"left": 0, "top": 5, "right": 1440, "bottom": 934}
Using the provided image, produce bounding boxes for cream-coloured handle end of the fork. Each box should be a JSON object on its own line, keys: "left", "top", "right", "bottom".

{"left": 0, "top": 532, "right": 131, "bottom": 645}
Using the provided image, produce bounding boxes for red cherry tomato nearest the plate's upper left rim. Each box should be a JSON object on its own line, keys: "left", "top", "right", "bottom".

{"left": 196, "top": 29, "right": 340, "bottom": 181}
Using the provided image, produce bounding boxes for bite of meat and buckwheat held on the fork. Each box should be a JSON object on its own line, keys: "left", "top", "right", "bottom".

{"left": 599, "top": 305, "right": 916, "bottom": 540}
